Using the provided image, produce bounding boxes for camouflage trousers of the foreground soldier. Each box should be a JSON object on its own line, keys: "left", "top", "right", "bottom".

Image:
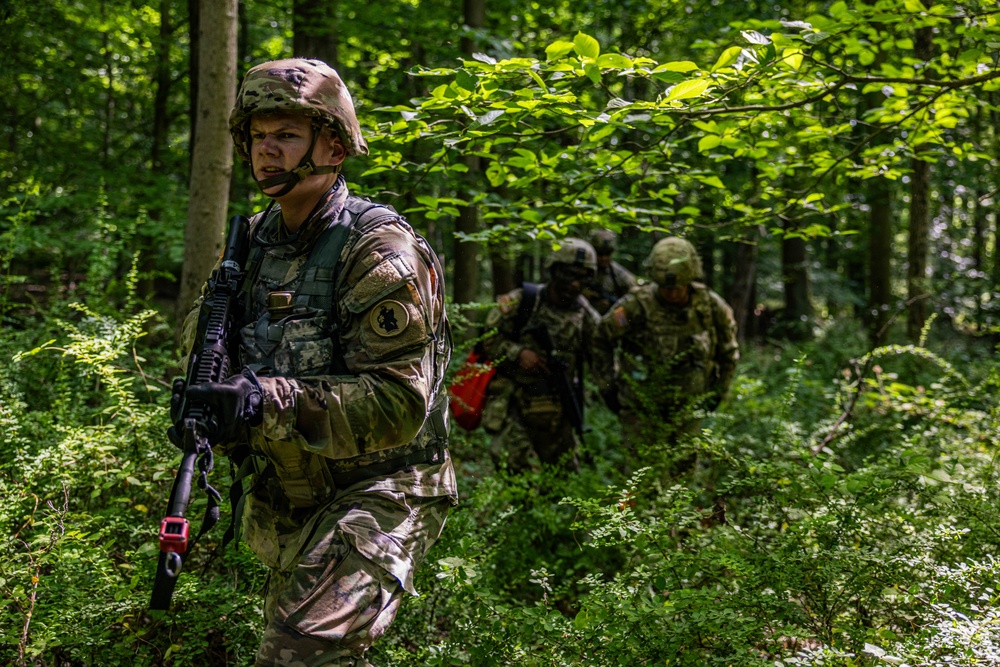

{"left": 255, "top": 497, "right": 451, "bottom": 667}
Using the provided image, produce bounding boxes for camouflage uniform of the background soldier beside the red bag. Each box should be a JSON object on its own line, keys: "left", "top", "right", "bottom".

{"left": 482, "top": 242, "right": 598, "bottom": 471}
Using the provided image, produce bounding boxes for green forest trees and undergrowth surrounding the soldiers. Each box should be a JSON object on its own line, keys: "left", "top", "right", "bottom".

{"left": 0, "top": 0, "right": 1000, "bottom": 667}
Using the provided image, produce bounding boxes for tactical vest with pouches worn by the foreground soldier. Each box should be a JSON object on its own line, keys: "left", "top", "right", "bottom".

{"left": 240, "top": 197, "right": 451, "bottom": 509}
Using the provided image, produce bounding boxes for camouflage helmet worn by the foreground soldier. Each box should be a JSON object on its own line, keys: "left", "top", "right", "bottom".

{"left": 229, "top": 58, "right": 368, "bottom": 162}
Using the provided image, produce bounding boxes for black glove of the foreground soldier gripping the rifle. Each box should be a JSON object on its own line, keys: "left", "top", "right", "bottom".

{"left": 185, "top": 368, "right": 264, "bottom": 445}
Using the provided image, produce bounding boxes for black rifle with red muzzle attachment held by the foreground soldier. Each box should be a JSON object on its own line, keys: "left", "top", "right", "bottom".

{"left": 149, "top": 215, "right": 250, "bottom": 610}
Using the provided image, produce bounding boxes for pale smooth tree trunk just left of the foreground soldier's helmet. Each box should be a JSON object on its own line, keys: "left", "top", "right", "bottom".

{"left": 177, "top": 0, "right": 237, "bottom": 315}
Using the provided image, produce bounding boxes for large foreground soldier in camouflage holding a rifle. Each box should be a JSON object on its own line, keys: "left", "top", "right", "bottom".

{"left": 172, "top": 58, "right": 457, "bottom": 667}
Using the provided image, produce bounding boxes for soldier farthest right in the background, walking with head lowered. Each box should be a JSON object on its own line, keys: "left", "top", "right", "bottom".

{"left": 594, "top": 237, "right": 739, "bottom": 460}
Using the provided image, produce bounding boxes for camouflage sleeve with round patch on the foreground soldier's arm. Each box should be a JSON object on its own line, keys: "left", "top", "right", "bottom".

{"left": 260, "top": 221, "right": 450, "bottom": 458}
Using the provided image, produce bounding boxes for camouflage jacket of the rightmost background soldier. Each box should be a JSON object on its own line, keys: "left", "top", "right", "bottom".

{"left": 594, "top": 282, "right": 739, "bottom": 410}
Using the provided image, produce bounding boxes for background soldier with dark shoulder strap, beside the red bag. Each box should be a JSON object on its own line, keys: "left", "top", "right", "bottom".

{"left": 482, "top": 238, "right": 598, "bottom": 471}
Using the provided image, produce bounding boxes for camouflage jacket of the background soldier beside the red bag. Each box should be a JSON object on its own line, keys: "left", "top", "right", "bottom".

{"left": 482, "top": 286, "right": 598, "bottom": 395}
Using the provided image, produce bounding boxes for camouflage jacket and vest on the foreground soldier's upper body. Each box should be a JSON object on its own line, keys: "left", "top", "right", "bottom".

{"left": 186, "top": 180, "right": 457, "bottom": 586}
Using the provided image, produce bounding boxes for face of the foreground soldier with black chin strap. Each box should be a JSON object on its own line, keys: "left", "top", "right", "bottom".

{"left": 250, "top": 114, "right": 346, "bottom": 196}
